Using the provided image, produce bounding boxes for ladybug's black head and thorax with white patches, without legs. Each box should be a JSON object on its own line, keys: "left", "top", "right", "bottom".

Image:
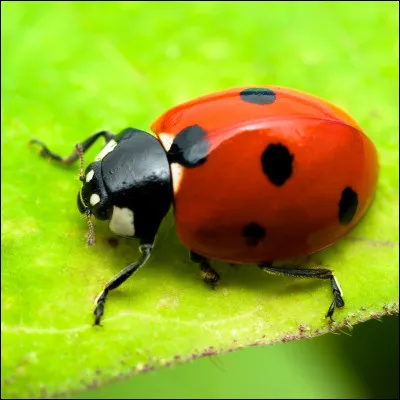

{"left": 78, "top": 128, "right": 172, "bottom": 243}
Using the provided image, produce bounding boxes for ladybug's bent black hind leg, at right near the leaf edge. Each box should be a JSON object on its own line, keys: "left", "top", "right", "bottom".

{"left": 259, "top": 264, "right": 344, "bottom": 321}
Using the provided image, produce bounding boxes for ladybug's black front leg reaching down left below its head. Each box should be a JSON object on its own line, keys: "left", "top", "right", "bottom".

{"left": 94, "top": 244, "right": 152, "bottom": 325}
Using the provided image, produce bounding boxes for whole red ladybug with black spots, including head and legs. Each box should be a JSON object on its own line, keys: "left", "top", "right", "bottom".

{"left": 31, "top": 86, "right": 378, "bottom": 325}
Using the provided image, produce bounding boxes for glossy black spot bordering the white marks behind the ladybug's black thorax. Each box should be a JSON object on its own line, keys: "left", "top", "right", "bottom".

{"left": 168, "top": 125, "right": 209, "bottom": 168}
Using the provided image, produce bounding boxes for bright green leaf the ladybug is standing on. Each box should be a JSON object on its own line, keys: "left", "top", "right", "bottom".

{"left": 1, "top": 2, "right": 399, "bottom": 398}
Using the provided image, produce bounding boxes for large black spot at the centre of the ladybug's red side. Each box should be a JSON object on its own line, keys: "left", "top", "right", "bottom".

{"left": 261, "top": 143, "right": 294, "bottom": 186}
